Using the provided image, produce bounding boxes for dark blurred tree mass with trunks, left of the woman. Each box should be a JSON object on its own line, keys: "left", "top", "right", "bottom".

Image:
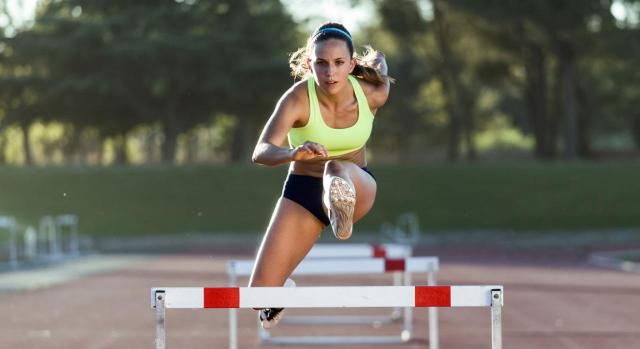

{"left": 0, "top": 0, "right": 297, "bottom": 162}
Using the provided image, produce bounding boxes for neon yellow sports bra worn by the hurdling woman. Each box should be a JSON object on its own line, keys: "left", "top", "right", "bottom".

{"left": 289, "top": 75, "right": 373, "bottom": 156}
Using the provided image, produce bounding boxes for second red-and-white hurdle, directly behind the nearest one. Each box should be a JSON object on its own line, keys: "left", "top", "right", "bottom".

{"left": 227, "top": 257, "right": 439, "bottom": 349}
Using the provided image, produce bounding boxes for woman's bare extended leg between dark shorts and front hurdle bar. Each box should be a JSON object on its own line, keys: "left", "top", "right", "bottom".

{"left": 249, "top": 198, "right": 324, "bottom": 287}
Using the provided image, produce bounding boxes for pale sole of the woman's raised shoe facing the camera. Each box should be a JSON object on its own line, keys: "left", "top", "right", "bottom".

{"left": 329, "top": 177, "right": 356, "bottom": 240}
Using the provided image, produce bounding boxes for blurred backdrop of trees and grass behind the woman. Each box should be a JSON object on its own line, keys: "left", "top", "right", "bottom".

{"left": 0, "top": 0, "right": 640, "bottom": 247}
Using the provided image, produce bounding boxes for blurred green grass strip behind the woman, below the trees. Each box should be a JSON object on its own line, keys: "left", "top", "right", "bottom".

{"left": 0, "top": 163, "right": 640, "bottom": 236}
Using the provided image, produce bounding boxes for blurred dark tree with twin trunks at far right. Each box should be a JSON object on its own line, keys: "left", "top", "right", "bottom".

{"left": 450, "top": 0, "right": 632, "bottom": 159}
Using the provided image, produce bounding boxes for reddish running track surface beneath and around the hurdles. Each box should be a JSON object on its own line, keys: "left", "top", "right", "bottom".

{"left": 0, "top": 251, "right": 640, "bottom": 349}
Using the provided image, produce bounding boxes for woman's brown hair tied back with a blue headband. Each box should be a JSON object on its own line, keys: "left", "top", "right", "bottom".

{"left": 289, "top": 22, "right": 394, "bottom": 85}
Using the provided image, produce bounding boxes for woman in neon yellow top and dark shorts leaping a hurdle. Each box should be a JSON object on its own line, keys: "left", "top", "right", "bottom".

{"left": 249, "top": 22, "right": 390, "bottom": 328}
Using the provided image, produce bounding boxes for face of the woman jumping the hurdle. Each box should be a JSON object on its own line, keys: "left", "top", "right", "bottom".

{"left": 308, "top": 39, "right": 355, "bottom": 94}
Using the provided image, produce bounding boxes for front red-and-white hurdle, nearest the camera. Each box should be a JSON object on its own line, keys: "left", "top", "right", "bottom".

{"left": 151, "top": 285, "right": 504, "bottom": 349}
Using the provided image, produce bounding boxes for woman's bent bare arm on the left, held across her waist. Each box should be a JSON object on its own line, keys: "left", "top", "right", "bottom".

{"left": 252, "top": 85, "right": 327, "bottom": 166}
